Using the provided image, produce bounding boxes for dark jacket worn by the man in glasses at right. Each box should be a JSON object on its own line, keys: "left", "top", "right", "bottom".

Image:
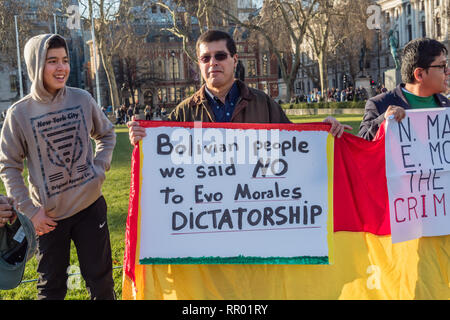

{"left": 358, "top": 83, "right": 450, "bottom": 141}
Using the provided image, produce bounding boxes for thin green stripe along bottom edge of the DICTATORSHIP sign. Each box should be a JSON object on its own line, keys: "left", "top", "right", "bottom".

{"left": 139, "top": 256, "right": 329, "bottom": 264}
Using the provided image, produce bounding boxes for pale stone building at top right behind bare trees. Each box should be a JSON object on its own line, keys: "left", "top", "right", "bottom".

{"left": 295, "top": 0, "right": 450, "bottom": 99}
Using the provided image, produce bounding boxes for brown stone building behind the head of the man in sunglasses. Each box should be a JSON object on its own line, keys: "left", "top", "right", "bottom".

{"left": 107, "top": 0, "right": 279, "bottom": 110}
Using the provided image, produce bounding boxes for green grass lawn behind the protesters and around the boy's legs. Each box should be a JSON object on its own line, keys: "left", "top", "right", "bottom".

{"left": 0, "top": 115, "right": 362, "bottom": 300}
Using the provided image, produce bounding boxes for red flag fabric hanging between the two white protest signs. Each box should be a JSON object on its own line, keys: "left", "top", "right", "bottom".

{"left": 333, "top": 125, "right": 391, "bottom": 235}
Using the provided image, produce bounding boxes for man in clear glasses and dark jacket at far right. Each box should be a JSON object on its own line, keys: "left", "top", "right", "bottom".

{"left": 358, "top": 38, "right": 450, "bottom": 140}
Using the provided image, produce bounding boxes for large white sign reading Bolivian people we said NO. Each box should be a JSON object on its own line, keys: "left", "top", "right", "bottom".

{"left": 139, "top": 123, "right": 333, "bottom": 264}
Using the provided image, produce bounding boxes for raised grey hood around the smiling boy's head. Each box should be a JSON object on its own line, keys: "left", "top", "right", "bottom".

{"left": 24, "top": 34, "right": 69, "bottom": 103}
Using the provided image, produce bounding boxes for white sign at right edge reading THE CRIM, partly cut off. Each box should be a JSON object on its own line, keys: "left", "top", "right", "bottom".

{"left": 385, "top": 109, "right": 450, "bottom": 243}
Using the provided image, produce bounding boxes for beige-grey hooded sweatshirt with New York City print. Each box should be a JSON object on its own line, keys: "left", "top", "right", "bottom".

{"left": 0, "top": 34, "right": 116, "bottom": 220}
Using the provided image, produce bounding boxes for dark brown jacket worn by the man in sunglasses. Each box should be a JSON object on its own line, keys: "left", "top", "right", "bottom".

{"left": 169, "top": 80, "right": 290, "bottom": 123}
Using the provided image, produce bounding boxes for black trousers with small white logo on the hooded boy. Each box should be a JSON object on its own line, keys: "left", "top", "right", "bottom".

{"left": 37, "top": 196, "right": 115, "bottom": 300}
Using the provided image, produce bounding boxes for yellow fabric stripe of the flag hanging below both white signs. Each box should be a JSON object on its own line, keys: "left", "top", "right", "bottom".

{"left": 122, "top": 232, "right": 450, "bottom": 300}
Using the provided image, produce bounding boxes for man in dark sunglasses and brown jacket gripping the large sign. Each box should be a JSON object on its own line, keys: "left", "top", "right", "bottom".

{"left": 127, "top": 30, "right": 351, "bottom": 145}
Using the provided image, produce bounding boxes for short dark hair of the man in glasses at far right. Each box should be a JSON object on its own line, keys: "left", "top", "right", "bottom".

{"left": 401, "top": 38, "right": 448, "bottom": 83}
